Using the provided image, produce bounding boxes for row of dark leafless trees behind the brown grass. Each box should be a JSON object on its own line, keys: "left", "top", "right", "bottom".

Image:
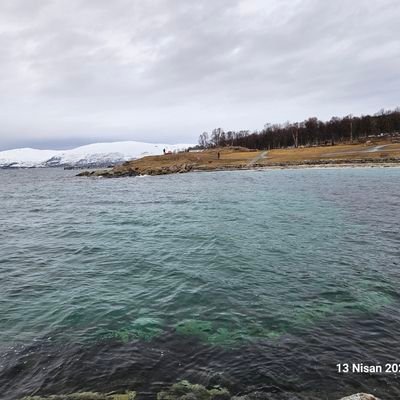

{"left": 199, "top": 107, "right": 400, "bottom": 150}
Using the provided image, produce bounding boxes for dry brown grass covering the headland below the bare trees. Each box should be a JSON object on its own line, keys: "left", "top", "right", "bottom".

{"left": 108, "top": 142, "right": 400, "bottom": 175}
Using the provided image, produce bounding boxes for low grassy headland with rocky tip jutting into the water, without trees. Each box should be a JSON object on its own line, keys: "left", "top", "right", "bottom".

{"left": 78, "top": 139, "right": 400, "bottom": 177}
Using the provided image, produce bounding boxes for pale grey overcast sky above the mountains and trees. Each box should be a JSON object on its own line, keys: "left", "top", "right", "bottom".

{"left": 0, "top": 0, "right": 400, "bottom": 150}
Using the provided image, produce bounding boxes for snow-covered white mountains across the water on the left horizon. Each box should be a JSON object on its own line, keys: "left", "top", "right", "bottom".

{"left": 0, "top": 141, "right": 193, "bottom": 168}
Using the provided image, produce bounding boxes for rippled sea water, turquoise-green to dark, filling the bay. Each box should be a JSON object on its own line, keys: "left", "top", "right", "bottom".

{"left": 0, "top": 169, "right": 400, "bottom": 399}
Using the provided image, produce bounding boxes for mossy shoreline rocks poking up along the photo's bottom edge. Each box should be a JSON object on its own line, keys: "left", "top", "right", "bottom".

{"left": 21, "top": 381, "right": 379, "bottom": 400}
